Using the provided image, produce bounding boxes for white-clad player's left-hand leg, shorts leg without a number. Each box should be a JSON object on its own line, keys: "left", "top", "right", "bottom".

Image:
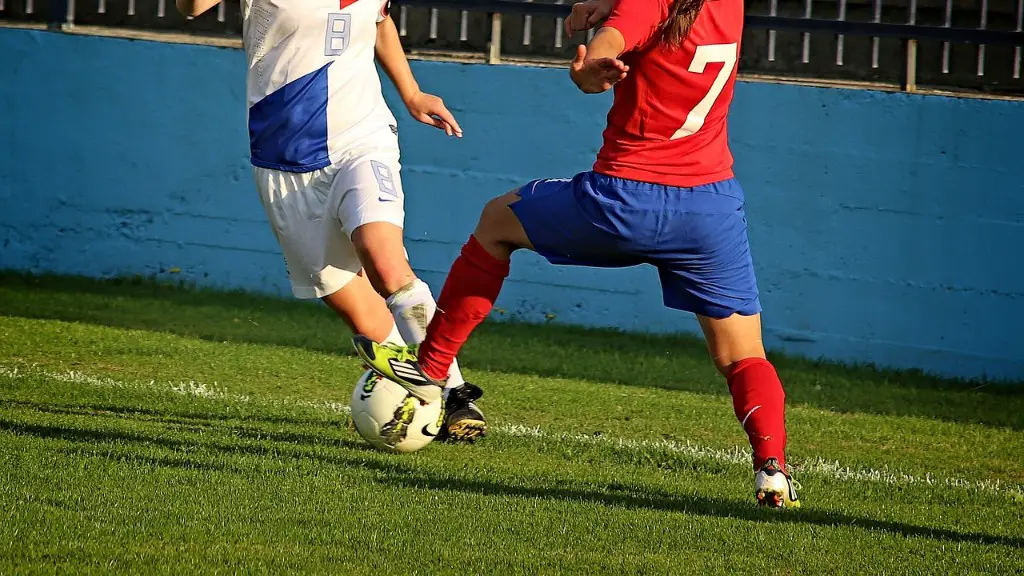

{"left": 253, "top": 167, "right": 403, "bottom": 344}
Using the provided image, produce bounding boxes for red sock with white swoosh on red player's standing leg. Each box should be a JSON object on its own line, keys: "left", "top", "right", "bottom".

{"left": 729, "top": 358, "right": 785, "bottom": 469}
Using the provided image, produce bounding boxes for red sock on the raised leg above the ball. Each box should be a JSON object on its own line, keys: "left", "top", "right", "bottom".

{"left": 419, "top": 236, "right": 509, "bottom": 380}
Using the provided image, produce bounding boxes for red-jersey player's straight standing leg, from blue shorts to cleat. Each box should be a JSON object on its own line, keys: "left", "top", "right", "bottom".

{"left": 658, "top": 180, "right": 799, "bottom": 506}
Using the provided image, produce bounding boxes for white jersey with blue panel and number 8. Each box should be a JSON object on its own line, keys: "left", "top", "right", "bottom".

{"left": 242, "top": 0, "right": 396, "bottom": 172}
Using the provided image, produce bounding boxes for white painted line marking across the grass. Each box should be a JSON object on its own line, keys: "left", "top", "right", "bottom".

{"left": 0, "top": 365, "right": 1024, "bottom": 497}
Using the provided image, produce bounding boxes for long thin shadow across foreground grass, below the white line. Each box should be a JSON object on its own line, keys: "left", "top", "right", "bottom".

{"left": 0, "top": 409, "right": 1024, "bottom": 548}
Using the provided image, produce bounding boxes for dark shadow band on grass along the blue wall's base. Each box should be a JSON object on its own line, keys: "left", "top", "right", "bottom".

{"left": 6, "top": 272, "right": 1024, "bottom": 429}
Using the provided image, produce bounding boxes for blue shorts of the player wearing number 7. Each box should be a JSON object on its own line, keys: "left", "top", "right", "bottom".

{"left": 511, "top": 172, "right": 761, "bottom": 318}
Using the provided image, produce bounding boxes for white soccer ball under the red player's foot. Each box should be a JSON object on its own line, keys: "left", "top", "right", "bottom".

{"left": 351, "top": 370, "right": 444, "bottom": 452}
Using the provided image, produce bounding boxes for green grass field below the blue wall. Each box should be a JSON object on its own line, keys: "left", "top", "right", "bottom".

{"left": 0, "top": 274, "right": 1024, "bottom": 574}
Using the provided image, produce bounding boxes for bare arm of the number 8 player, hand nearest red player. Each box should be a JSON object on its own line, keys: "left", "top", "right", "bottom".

{"left": 376, "top": 16, "right": 462, "bottom": 138}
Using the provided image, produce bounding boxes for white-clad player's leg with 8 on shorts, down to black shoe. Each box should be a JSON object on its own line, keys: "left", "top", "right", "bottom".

{"left": 332, "top": 148, "right": 486, "bottom": 440}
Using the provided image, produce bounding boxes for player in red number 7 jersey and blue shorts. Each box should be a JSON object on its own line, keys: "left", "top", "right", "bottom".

{"left": 355, "top": 0, "right": 799, "bottom": 507}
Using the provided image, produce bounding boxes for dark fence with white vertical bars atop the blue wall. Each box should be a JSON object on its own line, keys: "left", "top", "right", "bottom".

{"left": 0, "top": 0, "right": 1024, "bottom": 95}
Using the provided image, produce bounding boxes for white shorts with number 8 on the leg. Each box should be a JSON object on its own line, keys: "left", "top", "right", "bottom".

{"left": 253, "top": 147, "right": 406, "bottom": 298}
